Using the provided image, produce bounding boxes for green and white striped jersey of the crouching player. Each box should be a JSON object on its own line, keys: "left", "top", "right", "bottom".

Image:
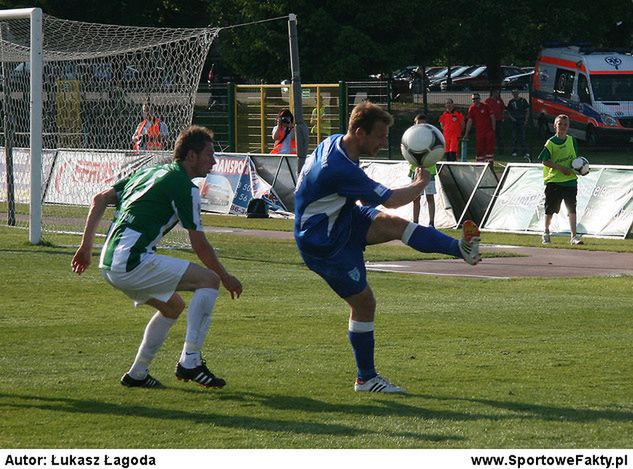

{"left": 99, "top": 163, "right": 203, "bottom": 272}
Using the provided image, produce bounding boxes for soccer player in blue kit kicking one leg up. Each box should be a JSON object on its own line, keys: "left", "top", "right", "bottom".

{"left": 295, "top": 102, "right": 481, "bottom": 393}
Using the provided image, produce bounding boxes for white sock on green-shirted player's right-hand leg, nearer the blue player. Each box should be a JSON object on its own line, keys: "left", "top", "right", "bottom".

{"left": 180, "top": 288, "right": 219, "bottom": 368}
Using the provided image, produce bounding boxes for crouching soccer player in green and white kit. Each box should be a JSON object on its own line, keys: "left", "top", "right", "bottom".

{"left": 72, "top": 126, "right": 242, "bottom": 388}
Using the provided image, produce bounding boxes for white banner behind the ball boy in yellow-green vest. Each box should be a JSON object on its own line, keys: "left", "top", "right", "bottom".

{"left": 482, "top": 163, "right": 633, "bottom": 238}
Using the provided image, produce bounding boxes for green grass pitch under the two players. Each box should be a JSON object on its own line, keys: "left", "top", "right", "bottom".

{"left": 0, "top": 221, "right": 633, "bottom": 448}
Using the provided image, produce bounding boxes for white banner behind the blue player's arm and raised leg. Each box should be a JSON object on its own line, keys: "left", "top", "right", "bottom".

{"left": 360, "top": 160, "right": 457, "bottom": 228}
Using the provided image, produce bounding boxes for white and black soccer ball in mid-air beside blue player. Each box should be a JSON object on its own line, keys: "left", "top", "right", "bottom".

{"left": 400, "top": 124, "right": 444, "bottom": 168}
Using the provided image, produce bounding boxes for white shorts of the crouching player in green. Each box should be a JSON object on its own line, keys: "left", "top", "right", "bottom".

{"left": 101, "top": 254, "right": 189, "bottom": 306}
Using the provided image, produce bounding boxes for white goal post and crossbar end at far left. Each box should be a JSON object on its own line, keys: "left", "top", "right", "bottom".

{"left": 0, "top": 8, "right": 44, "bottom": 244}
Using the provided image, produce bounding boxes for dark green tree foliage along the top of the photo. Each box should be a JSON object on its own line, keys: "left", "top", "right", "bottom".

{"left": 3, "top": 0, "right": 633, "bottom": 83}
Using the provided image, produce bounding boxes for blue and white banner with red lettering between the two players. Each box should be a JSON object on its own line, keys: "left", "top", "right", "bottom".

{"left": 194, "top": 153, "right": 286, "bottom": 215}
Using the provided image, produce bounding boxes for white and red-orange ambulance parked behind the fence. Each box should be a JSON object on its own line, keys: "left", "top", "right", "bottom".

{"left": 530, "top": 45, "right": 633, "bottom": 144}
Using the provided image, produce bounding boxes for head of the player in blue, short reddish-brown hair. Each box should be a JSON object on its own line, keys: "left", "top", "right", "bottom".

{"left": 347, "top": 101, "right": 393, "bottom": 157}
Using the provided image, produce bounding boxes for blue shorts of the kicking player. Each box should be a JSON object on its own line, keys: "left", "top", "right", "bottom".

{"left": 299, "top": 206, "right": 380, "bottom": 298}
